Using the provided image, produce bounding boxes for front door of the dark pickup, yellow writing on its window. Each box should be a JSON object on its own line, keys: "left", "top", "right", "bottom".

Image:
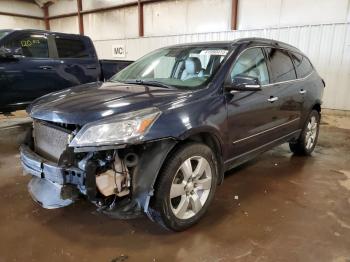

{"left": 0, "top": 32, "right": 55, "bottom": 107}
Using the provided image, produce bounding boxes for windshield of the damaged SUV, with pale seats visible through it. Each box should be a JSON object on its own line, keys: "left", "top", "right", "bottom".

{"left": 110, "top": 46, "right": 229, "bottom": 89}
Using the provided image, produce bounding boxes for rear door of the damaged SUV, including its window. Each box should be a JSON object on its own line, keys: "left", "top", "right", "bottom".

{"left": 265, "top": 48, "right": 302, "bottom": 137}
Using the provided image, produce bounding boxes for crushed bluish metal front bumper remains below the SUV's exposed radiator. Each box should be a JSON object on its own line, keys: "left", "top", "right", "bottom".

{"left": 20, "top": 145, "right": 85, "bottom": 209}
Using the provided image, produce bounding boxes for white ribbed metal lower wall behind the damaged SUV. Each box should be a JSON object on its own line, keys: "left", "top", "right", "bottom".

{"left": 94, "top": 23, "right": 350, "bottom": 110}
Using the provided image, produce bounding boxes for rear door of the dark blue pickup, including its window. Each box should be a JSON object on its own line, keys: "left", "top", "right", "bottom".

{"left": 53, "top": 34, "right": 101, "bottom": 87}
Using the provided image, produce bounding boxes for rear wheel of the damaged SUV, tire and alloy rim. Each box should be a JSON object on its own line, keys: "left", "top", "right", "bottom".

{"left": 289, "top": 110, "right": 320, "bottom": 156}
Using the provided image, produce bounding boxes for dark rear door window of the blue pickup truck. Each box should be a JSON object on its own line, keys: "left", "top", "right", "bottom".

{"left": 56, "top": 36, "right": 89, "bottom": 58}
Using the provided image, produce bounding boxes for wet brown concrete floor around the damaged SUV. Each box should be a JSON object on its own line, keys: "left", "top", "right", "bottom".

{"left": 0, "top": 115, "right": 350, "bottom": 262}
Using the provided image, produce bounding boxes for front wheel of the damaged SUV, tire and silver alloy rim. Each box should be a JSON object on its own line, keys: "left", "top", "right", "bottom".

{"left": 149, "top": 143, "right": 218, "bottom": 231}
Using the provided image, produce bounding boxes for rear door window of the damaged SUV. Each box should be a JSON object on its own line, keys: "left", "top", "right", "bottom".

{"left": 266, "top": 48, "right": 296, "bottom": 83}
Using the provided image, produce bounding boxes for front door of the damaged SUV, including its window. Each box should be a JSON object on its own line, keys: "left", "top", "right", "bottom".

{"left": 227, "top": 47, "right": 278, "bottom": 159}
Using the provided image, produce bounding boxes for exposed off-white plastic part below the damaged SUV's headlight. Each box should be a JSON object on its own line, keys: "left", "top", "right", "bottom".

{"left": 96, "top": 153, "right": 130, "bottom": 197}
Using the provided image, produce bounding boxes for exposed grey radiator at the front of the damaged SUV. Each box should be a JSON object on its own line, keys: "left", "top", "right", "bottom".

{"left": 33, "top": 120, "right": 71, "bottom": 163}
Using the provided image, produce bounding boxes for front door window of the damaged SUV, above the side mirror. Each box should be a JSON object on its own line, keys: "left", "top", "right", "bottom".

{"left": 231, "top": 48, "right": 270, "bottom": 85}
